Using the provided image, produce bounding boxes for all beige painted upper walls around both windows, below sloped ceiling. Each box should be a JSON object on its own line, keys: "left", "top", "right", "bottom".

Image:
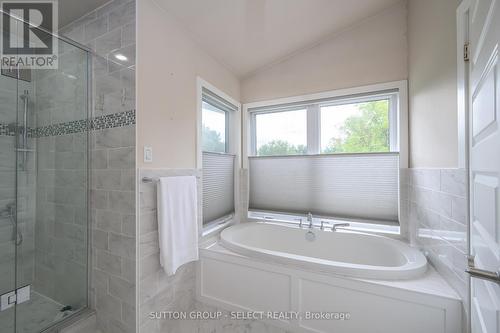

{"left": 137, "top": 0, "right": 459, "bottom": 168}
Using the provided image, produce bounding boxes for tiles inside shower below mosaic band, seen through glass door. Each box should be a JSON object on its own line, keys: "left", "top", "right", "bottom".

{"left": 34, "top": 132, "right": 88, "bottom": 309}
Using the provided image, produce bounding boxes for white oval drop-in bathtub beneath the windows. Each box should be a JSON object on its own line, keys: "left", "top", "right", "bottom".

{"left": 221, "top": 222, "right": 427, "bottom": 280}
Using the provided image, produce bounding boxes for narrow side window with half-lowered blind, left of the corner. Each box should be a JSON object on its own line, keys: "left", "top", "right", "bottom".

{"left": 200, "top": 87, "right": 238, "bottom": 229}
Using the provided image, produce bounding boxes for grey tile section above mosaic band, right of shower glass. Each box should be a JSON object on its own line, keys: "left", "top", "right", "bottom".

{"left": 60, "top": 0, "right": 135, "bottom": 116}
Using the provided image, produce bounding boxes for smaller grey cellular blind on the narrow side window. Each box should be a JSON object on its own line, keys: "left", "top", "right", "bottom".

{"left": 202, "top": 152, "right": 235, "bottom": 225}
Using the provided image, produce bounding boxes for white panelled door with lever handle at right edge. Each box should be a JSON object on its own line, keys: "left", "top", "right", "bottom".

{"left": 469, "top": 0, "right": 500, "bottom": 333}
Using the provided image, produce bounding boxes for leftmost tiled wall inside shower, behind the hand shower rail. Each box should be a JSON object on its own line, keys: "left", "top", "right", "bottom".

{"left": 0, "top": 76, "right": 36, "bottom": 296}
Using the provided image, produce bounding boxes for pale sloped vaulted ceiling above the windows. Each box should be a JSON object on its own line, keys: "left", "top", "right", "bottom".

{"left": 155, "top": 0, "right": 399, "bottom": 77}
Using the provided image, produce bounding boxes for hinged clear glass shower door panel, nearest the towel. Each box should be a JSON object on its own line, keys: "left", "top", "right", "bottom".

{"left": 15, "top": 24, "right": 89, "bottom": 333}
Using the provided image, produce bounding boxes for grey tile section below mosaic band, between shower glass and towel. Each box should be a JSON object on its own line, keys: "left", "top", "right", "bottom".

{"left": 90, "top": 125, "right": 136, "bottom": 332}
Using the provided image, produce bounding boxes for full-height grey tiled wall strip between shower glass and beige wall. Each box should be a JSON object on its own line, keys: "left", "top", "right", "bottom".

{"left": 60, "top": 0, "right": 136, "bottom": 333}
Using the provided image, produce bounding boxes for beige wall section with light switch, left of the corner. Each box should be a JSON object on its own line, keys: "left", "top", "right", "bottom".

{"left": 137, "top": 0, "right": 240, "bottom": 168}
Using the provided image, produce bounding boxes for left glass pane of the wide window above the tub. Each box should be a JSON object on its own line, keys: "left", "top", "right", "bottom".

{"left": 255, "top": 109, "right": 307, "bottom": 156}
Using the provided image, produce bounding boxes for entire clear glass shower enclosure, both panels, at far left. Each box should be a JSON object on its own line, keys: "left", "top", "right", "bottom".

{"left": 0, "top": 10, "right": 90, "bottom": 333}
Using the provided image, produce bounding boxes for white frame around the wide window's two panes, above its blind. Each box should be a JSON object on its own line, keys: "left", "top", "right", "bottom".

{"left": 246, "top": 90, "right": 400, "bottom": 156}
